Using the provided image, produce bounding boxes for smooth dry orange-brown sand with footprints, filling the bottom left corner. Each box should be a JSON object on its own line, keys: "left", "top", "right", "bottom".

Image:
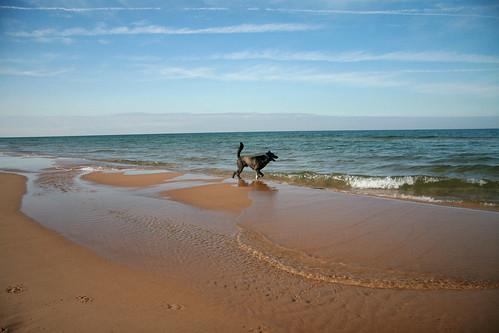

{"left": 0, "top": 173, "right": 258, "bottom": 332}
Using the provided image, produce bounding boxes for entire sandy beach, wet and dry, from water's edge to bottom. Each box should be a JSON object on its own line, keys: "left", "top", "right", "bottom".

{"left": 0, "top": 168, "right": 499, "bottom": 332}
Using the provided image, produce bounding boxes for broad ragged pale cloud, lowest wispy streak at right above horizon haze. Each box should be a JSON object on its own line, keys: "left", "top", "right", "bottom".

{"left": 143, "top": 64, "right": 499, "bottom": 97}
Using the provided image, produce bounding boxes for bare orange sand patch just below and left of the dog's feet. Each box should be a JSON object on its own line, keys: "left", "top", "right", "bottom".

{"left": 161, "top": 183, "right": 251, "bottom": 214}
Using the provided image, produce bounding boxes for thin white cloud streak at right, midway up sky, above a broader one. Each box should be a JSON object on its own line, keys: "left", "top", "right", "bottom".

{"left": 210, "top": 50, "right": 499, "bottom": 64}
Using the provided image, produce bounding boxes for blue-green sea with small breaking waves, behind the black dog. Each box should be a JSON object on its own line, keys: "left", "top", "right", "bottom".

{"left": 0, "top": 129, "right": 499, "bottom": 207}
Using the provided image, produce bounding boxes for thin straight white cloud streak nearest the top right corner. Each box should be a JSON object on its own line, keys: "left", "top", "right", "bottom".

{"left": 264, "top": 8, "right": 499, "bottom": 19}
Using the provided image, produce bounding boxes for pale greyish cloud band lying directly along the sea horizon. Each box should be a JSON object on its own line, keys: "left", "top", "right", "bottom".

{"left": 0, "top": 112, "right": 499, "bottom": 137}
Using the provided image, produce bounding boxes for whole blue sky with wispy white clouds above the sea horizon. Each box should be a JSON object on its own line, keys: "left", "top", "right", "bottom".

{"left": 0, "top": 0, "right": 499, "bottom": 136}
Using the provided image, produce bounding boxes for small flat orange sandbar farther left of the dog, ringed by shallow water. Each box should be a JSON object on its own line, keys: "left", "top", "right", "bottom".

{"left": 82, "top": 172, "right": 182, "bottom": 187}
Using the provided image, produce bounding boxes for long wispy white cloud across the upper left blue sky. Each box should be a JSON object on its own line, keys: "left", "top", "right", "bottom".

{"left": 7, "top": 23, "right": 319, "bottom": 38}
